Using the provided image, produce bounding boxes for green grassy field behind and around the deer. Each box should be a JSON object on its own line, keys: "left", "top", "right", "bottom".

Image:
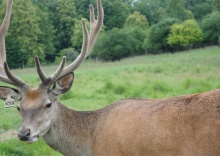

{"left": 0, "top": 47, "right": 220, "bottom": 156}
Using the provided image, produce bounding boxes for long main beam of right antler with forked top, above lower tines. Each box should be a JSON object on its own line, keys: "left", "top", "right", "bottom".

{"left": 56, "top": 0, "right": 104, "bottom": 78}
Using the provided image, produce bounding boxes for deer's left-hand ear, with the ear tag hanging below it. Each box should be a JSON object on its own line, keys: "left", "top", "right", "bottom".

{"left": 0, "top": 86, "right": 21, "bottom": 101}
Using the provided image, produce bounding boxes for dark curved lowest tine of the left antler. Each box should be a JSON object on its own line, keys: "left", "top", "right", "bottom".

{"left": 4, "top": 62, "right": 28, "bottom": 87}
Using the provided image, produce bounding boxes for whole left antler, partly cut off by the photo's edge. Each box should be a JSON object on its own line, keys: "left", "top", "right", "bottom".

{"left": 0, "top": 0, "right": 27, "bottom": 87}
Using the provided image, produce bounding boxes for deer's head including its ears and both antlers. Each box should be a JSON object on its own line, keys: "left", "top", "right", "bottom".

{"left": 0, "top": 0, "right": 104, "bottom": 142}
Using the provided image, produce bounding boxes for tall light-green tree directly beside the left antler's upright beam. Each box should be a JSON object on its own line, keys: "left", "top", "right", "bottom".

{"left": 0, "top": 0, "right": 45, "bottom": 68}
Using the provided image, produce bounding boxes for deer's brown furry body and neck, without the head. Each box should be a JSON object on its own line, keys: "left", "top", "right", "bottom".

{"left": 40, "top": 90, "right": 220, "bottom": 156}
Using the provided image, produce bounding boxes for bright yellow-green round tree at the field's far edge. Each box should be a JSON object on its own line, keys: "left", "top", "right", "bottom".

{"left": 167, "top": 20, "right": 203, "bottom": 47}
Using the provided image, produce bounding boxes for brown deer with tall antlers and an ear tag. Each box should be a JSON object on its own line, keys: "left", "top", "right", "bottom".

{"left": 0, "top": 0, "right": 220, "bottom": 156}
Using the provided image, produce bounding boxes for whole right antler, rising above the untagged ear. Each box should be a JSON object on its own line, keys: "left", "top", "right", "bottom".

{"left": 35, "top": 0, "right": 104, "bottom": 87}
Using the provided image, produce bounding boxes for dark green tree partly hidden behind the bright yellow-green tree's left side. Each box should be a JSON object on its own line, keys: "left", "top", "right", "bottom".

{"left": 143, "top": 18, "right": 179, "bottom": 53}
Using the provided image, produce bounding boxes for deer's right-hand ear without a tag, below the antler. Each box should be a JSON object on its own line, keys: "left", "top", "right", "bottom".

{"left": 52, "top": 72, "right": 74, "bottom": 95}
